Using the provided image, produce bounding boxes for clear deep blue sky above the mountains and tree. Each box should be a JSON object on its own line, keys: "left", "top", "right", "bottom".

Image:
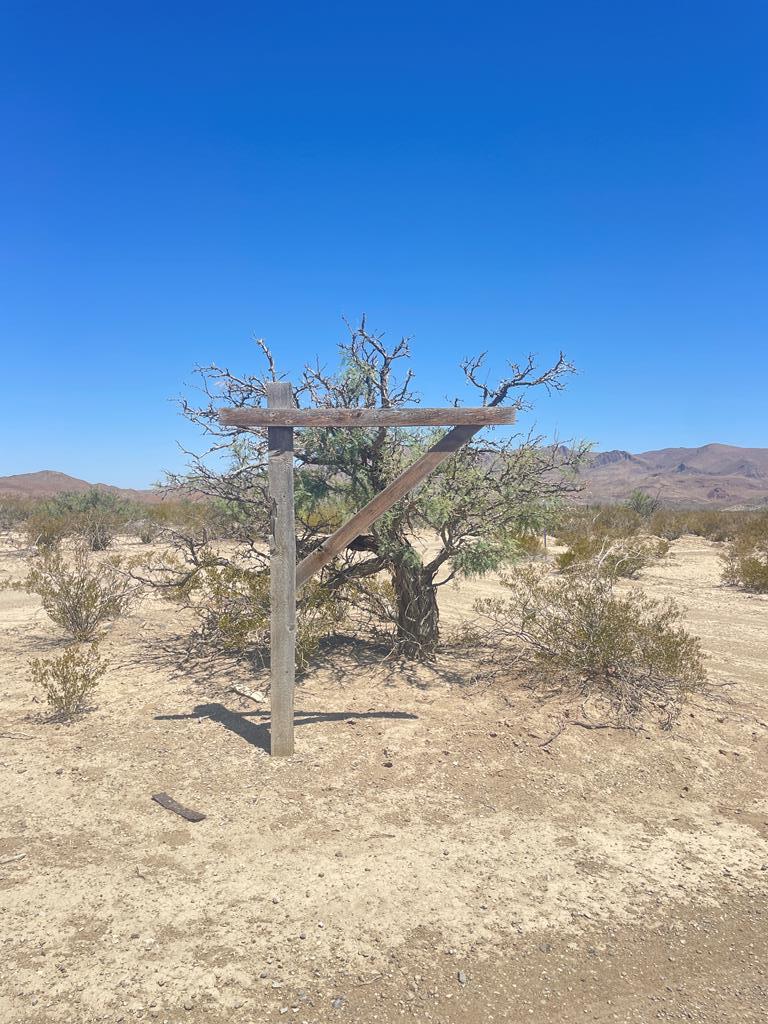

{"left": 0, "top": 0, "right": 768, "bottom": 486}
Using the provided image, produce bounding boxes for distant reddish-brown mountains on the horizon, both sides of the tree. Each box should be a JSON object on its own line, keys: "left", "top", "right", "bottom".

{"left": 0, "top": 444, "right": 768, "bottom": 508}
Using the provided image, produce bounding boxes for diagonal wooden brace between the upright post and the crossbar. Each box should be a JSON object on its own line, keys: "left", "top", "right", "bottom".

{"left": 296, "top": 410, "right": 514, "bottom": 588}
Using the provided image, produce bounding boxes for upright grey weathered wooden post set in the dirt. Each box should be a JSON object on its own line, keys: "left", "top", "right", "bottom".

{"left": 266, "top": 382, "right": 296, "bottom": 757}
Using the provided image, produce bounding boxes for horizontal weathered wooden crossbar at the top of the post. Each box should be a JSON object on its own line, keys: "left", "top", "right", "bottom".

{"left": 219, "top": 403, "right": 515, "bottom": 430}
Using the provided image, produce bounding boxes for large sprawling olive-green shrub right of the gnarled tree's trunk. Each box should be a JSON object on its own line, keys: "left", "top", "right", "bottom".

{"left": 475, "top": 566, "right": 706, "bottom": 724}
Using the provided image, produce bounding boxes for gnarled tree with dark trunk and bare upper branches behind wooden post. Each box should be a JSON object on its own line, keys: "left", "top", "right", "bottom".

{"left": 166, "top": 321, "right": 586, "bottom": 659}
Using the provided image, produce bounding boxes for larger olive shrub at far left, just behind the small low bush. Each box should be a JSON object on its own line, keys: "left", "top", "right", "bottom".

{"left": 15, "top": 544, "right": 137, "bottom": 641}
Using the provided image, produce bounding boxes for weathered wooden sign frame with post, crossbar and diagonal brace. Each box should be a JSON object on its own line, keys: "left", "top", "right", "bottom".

{"left": 219, "top": 381, "right": 515, "bottom": 757}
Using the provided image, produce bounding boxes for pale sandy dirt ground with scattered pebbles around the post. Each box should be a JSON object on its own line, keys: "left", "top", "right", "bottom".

{"left": 0, "top": 538, "right": 768, "bottom": 1024}
